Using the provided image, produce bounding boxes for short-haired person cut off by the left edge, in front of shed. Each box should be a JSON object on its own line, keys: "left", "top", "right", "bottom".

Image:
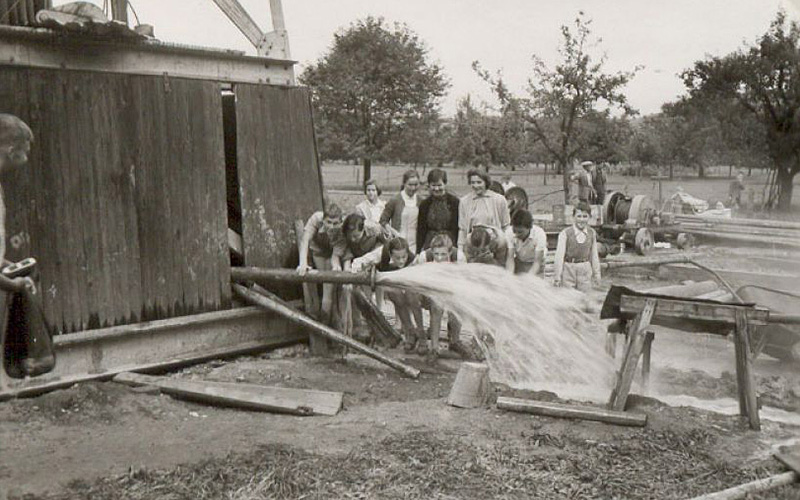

{"left": 0, "top": 113, "right": 33, "bottom": 287}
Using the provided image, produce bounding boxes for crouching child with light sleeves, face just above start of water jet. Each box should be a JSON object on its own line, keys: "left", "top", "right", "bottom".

{"left": 414, "top": 234, "right": 471, "bottom": 361}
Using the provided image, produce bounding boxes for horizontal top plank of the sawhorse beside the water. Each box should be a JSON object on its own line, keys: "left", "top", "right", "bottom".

{"left": 620, "top": 295, "right": 769, "bottom": 325}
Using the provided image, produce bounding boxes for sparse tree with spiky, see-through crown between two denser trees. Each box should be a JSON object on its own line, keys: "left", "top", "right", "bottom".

{"left": 473, "top": 12, "right": 638, "bottom": 201}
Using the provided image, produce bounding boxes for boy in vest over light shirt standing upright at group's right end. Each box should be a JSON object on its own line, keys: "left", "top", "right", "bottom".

{"left": 553, "top": 201, "right": 600, "bottom": 292}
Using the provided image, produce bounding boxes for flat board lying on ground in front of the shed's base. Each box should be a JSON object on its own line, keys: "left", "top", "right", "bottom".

{"left": 112, "top": 372, "right": 344, "bottom": 416}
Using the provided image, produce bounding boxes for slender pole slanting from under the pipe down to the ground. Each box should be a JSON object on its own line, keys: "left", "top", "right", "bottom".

{"left": 233, "top": 284, "right": 419, "bottom": 378}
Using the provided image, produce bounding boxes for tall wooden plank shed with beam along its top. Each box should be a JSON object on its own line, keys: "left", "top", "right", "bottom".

{"left": 0, "top": 2, "right": 322, "bottom": 342}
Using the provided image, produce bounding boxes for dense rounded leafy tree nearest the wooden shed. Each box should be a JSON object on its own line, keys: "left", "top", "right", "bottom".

{"left": 300, "top": 17, "right": 449, "bottom": 180}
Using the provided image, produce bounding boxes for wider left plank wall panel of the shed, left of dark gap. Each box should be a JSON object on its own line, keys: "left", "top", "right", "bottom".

{"left": 0, "top": 68, "right": 230, "bottom": 332}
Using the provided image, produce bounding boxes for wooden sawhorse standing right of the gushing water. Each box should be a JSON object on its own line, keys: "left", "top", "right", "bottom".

{"left": 608, "top": 295, "right": 769, "bottom": 430}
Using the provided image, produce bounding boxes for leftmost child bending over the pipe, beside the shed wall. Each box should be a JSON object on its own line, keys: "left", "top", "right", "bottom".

{"left": 297, "top": 203, "right": 343, "bottom": 324}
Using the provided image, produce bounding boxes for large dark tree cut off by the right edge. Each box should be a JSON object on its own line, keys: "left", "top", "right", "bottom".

{"left": 682, "top": 12, "right": 800, "bottom": 211}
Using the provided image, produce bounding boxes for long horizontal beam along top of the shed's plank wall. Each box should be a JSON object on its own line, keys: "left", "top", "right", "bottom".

{"left": 0, "top": 26, "right": 295, "bottom": 86}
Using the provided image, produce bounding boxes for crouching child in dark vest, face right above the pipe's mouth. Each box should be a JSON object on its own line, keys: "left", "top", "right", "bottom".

{"left": 350, "top": 236, "right": 426, "bottom": 354}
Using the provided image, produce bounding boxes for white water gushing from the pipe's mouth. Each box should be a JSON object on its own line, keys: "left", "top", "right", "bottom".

{"left": 378, "top": 263, "right": 614, "bottom": 398}
